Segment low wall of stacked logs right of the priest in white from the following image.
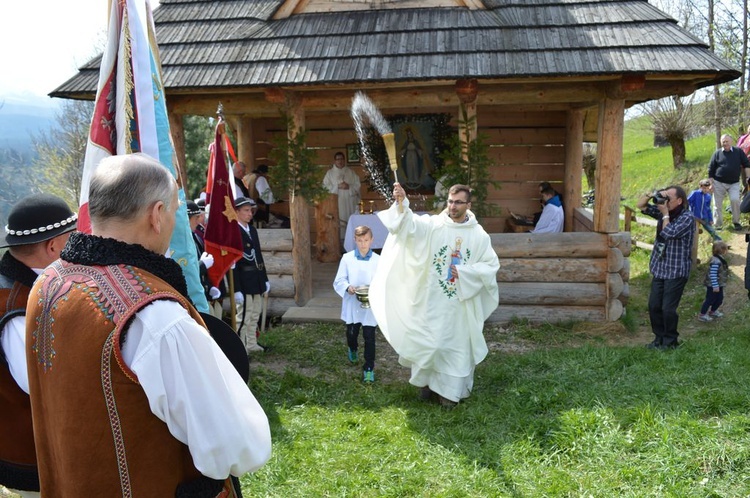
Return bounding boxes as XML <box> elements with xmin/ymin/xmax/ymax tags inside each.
<box><xmin>488</xmin><ymin>232</ymin><xmax>631</xmax><ymax>323</ymax></box>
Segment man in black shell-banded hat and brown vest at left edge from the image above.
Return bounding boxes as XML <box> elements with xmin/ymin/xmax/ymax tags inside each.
<box><xmin>0</xmin><ymin>194</ymin><xmax>77</xmax><ymax>497</ymax></box>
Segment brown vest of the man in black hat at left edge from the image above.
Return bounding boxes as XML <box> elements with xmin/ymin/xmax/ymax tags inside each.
<box><xmin>0</xmin><ymin>276</ymin><xmax>39</xmax><ymax>491</ymax></box>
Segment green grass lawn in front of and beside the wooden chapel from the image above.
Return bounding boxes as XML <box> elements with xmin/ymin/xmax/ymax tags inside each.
<box><xmin>236</xmin><ymin>121</ymin><xmax>750</xmax><ymax>497</ymax></box>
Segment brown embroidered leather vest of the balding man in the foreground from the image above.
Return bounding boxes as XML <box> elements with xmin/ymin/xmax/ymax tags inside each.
<box><xmin>26</xmin><ymin>260</ymin><xmax>234</xmax><ymax>498</ymax></box>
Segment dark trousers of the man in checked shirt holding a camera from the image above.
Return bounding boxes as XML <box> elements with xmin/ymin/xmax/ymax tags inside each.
<box><xmin>648</xmin><ymin>277</ymin><xmax>687</xmax><ymax>346</ymax></box>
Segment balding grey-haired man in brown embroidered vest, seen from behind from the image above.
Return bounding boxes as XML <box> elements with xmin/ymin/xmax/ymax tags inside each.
<box><xmin>26</xmin><ymin>154</ymin><xmax>271</xmax><ymax>498</ymax></box>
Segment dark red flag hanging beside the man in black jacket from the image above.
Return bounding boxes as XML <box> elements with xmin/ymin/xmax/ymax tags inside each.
<box><xmin>203</xmin><ymin>122</ymin><xmax>242</xmax><ymax>287</ymax></box>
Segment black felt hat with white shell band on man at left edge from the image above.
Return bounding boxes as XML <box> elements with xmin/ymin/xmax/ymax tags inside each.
<box><xmin>0</xmin><ymin>194</ymin><xmax>78</xmax><ymax>247</ymax></box>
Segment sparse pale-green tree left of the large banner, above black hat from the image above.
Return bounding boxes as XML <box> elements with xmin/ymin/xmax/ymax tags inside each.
<box><xmin>32</xmin><ymin>100</ymin><xmax>94</xmax><ymax>206</ymax></box>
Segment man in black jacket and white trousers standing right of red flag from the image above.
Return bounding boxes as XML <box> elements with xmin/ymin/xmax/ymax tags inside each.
<box><xmin>234</xmin><ymin>197</ymin><xmax>271</xmax><ymax>354</ymax></box>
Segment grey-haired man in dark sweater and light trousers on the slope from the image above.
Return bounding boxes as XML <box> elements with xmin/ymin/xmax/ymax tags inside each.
<box><xmin>708</xmin><ymin>135</ymin><xmax>750</xmax><ymax>230</ymax></box>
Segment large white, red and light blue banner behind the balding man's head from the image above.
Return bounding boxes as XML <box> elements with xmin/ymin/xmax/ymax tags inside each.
<box><xmin>78</xmin><ymin>0</ymin><xmax>208</xmax><ymax>312</ymax></box>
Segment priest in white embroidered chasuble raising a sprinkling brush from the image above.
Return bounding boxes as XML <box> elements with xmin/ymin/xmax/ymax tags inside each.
<box><xmin>369</xmin><ymin>183</ymin><xmax>499</xmax><ymax>407</ymax></box>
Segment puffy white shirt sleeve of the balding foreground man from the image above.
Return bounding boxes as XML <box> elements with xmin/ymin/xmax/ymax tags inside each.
<box><xmin>122</xmin><ymin>300</ymin><xmax>271</xmax><ymax>479</ymax></box>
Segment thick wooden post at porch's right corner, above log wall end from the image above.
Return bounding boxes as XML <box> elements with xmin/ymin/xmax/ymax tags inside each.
<box><xmin>594</xmin><ymin>98</ymin><xmax>625</xmax><ymax>233</ymax></box>
